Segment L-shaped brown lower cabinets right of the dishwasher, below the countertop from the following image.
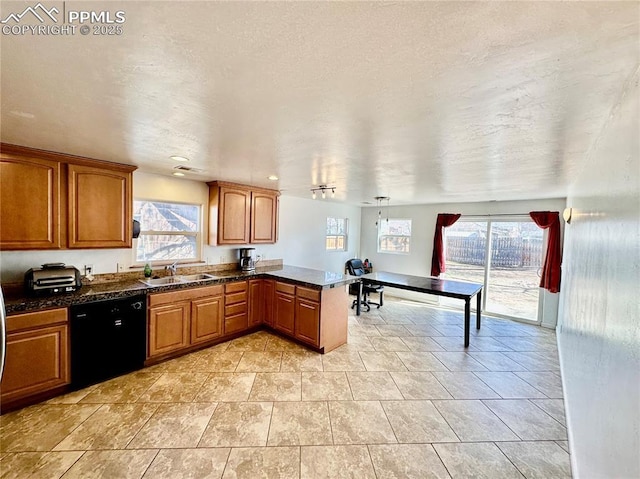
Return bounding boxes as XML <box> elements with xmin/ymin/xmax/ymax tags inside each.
<box><xmin>147</xmin><ymin>278</ymin><xmax>347</xmax><ymax>362</ymax></box>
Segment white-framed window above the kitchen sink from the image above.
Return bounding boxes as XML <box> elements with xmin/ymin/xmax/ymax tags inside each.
<box><xmin>133</xmin><ymin>200</ymin><xmax>201</xmax><ymax>263</ymax></box>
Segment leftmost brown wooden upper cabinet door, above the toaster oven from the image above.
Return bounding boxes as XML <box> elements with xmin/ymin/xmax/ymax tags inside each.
<box><xmin>0</xmin><ymin>154</ymin><xmax>66</xmax><ymax>250</ymax></box>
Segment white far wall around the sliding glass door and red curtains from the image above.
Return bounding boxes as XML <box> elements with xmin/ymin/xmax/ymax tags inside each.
<box><xmin>361</xmin><ymin>199</ymin><xmax>566</xmax><ymax>327</ymax></box>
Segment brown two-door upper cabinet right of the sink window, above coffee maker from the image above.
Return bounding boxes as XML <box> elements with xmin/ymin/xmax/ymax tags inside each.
<box><xmin>207</xmin><ymin>181</ymin><xmax>280</xmax><ymax>245</ymax></box>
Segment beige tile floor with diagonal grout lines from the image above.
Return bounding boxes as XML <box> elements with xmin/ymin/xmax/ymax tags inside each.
<box><xmin>0</xmin><ymin>298</ymin><xmax>571</xmax><ymax>479</ymax></box>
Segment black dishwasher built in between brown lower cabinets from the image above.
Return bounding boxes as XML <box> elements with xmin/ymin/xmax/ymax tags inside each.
<box><xmin>71</xmin><ymin>295</ymin><xmax>147</xmax><ymax>389</ymax></box>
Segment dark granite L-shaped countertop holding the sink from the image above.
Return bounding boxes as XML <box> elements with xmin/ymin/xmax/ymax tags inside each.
<box><xmin>5</xmin><ymin>265</ymin><xmax>358</xmax><ymax>314</ymax></box>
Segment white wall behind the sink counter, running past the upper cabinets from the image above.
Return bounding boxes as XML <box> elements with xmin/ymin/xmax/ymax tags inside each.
<box><xmin>0</xmin><ymin>171</ymin><xmax>360</xmax><ymax>282</ymax></box>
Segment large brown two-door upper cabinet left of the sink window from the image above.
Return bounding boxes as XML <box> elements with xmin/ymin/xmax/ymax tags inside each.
<box><xmin>0</xmin><ymin>143</ymin><xmax>136</xmax><ymax>250</ymax></box>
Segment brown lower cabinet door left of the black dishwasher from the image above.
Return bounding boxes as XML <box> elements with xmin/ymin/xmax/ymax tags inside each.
<box><xmin>0</xmin><ymin>324</ymin><xmax>69</xmax><ymax>403</ymax></box>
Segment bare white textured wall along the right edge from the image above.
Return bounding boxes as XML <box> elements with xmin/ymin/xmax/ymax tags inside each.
<box><xmin>558</xmin><ymin>71</ymin><xmax>640</xmax><ymax>479</ymax></box>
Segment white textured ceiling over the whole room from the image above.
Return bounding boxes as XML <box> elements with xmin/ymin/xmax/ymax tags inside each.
<box><xmin>0</xmin><ymin>1</ymin><xmax>640</xmax><ymax>204</ymax></box>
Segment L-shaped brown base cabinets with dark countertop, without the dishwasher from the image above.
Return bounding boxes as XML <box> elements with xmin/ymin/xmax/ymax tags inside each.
<box><xmin>1</xmin><ymin>265</ymin><xmax>357</xmax><ymax>410</ymax></box>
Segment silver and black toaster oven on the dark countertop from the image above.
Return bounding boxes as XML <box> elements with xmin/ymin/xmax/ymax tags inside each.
<box><xmin>24</xmin><ymin>263</ymin><xmax>82</xmax><ymax>296</ymax></box>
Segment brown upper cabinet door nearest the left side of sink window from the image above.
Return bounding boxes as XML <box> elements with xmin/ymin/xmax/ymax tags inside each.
<box><xmin>68</xmin><ymin>165</ymin><xmax>133</xmax><ymax>248</ymax></box>
